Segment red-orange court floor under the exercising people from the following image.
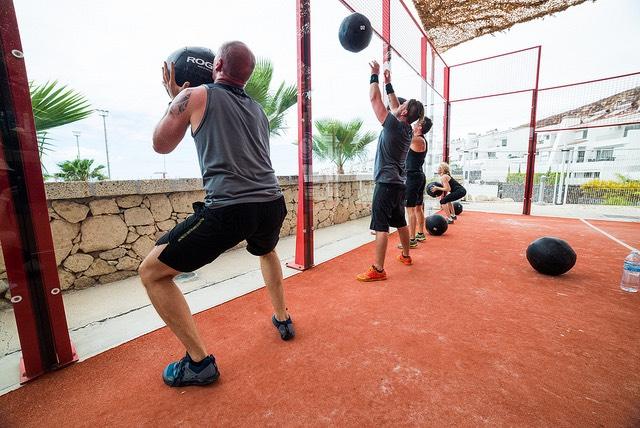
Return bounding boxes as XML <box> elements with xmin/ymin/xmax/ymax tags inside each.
<box><xmin>0</xmin><ymin>212</ymin><xmax>640</xmax><ymax>427</ymax></box>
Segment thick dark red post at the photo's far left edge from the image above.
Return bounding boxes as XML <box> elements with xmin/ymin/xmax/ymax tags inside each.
<box><xmin>0</xmin><ymin>0</ymin><xmax>78</xmax><ymax>382</ymax></box>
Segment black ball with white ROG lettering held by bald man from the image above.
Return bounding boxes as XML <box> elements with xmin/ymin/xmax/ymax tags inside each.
<box><xmin>167</xmin><ymin>47</ymin><xmax>215</xmax><ymax>88</ymax></box>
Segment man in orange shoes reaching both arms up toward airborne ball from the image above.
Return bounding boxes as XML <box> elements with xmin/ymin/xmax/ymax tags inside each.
<box><xmin>357</xmin><ymin>61</ymin><xmax>424</xmax><ymax>281</ymax></box>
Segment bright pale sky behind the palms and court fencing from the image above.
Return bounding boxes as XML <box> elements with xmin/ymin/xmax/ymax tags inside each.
<box><xmin>14</xmin><ymin>0</ymin><xmax>640</xmax><ymax>179</ymax></box>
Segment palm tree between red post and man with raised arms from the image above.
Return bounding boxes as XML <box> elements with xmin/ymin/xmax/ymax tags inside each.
<box><xmin>313</xmin><ymin>119</ymin><xmax>377</xmax><ymax>174</ymax></box>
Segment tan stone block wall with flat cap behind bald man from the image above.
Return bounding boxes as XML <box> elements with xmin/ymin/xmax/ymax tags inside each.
<box><xmin>0</xmin><ymin>176</ymin><xmax>373</xmax><ymax>306</ymax></box>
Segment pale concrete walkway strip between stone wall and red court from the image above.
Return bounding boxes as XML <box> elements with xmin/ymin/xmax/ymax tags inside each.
<box><xmin>0</xmin><ymin>217</ymin><xmax>374</xmax><ymax>395</ymax></box>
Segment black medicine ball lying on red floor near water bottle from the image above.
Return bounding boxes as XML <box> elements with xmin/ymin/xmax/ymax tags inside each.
<box><xmin>527</xmin><ymin>236</ymin><xmax>577</xmax><ymax>276</ymax></box>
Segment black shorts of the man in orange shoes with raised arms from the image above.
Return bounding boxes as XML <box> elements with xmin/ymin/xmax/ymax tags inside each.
<box><xmin>369</xmin><ymin>183</ymin><xmax>407</xmax><ymax>232</ymax></box>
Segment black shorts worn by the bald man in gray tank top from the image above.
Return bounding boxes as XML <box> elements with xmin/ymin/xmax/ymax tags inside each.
<box><xmin>156</xmin><ymin>198</ymin><xmax>287</xmax><ymax>272</ymax></box>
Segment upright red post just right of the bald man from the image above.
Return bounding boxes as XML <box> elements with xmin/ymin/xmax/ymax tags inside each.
<box><xmin>287</xmin><ymin>0</ymin><xmax>313</xmax><ymax>270</ymax></box>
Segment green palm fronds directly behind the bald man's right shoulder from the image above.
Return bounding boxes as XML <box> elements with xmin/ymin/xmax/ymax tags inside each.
<box><xmin>244</xmin><ymin>58</ymin><xmax>298</xmax><ymax>135</ymax></box>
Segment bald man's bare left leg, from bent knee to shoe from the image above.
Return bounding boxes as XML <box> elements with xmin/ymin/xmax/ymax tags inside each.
<box><xmin>139</xmin><ymin>244</ymin><xmax>208</xmax><ymax>361</ymax></box>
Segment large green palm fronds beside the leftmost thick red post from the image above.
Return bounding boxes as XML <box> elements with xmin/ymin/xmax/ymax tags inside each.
<box><xmin>29</xmin><ymin>80</ymin><xmax>93</xmax><ymax>158</ymax></box>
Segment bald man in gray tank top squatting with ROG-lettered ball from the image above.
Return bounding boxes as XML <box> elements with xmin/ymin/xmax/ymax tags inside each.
<box><xmin>140</xmin><ymin>41</ymin><xmax>295</xmax><ymax>386</ymax></box>
